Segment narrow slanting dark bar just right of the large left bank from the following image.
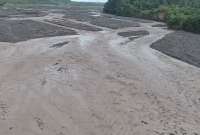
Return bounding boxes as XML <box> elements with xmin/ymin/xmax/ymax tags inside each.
<box><xmin>46</xmin><ymin>20</ymin><xmax>102</xmax><ymax>31</ymax></box>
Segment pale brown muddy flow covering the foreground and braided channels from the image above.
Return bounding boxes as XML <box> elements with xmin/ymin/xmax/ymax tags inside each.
<box><xmin>0</xmin><ymin>4</ymin><xmax>200</xmax><ymax>135</ymax></box>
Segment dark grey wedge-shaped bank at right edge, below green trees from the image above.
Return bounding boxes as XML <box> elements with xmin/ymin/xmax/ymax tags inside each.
<box><xmin>151</xmin><ymin>31</ymin><xmax>200</xmax><ymax>67</ymax></box>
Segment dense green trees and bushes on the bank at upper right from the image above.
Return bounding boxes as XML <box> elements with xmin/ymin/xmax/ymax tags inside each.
<box><xmin>104</xmin><ymin>0</ymin><xmax>200</xmax><ymax>33</ymax></box>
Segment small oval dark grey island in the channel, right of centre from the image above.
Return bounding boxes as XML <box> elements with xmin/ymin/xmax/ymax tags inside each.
<box><xmin>118</xmin><ymin>30</ymin><xmax>149</xmax><ymax>37</ymax></box>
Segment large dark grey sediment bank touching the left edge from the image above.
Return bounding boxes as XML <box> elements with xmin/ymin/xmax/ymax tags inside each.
<box><xmin>0</xmin><ymin>20</ymin><xmax>77</xmax><ymax>43</ymax></box>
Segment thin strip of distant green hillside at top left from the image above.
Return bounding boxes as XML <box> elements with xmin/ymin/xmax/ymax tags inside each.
<box><xmin>0</xmin><ymin>0</ymin><xmax>70</xmax><ymax>4</ymax></box>
